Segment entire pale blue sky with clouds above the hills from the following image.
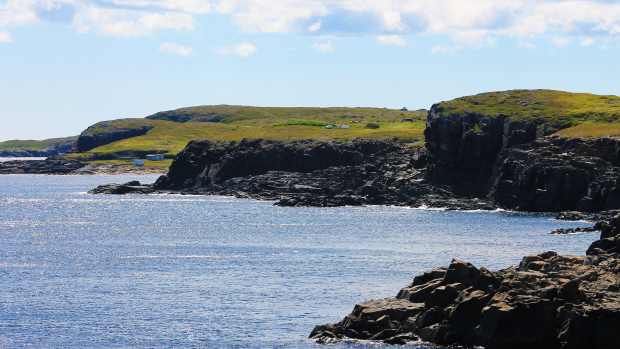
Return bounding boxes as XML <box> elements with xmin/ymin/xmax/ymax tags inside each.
<box><xmin>0</xmin><ymin>0</ymin><xmax>620</xmax><ymax>140</ymax></box>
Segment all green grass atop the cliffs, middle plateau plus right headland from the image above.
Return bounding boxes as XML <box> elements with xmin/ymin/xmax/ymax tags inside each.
<box><xmin>54</xmin><ymin>90</ymin><xmax>620</xmax><ymax>171</ymax></box>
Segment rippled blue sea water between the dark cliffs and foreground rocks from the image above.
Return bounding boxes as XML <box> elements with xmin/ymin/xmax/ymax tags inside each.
<box><xmin>0</xmin><ymin>175</ymin><xmax>596</xmax><ymax>349</ymax></box>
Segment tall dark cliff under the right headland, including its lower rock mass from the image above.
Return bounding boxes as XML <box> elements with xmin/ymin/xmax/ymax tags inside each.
<box><xmin>425</xmin><ymin>105</ymin><xmax>620</xmax><ymax>212</ymax></box>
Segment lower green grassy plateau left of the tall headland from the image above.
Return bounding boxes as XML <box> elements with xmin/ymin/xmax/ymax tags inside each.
<box><xmin>72</xmin><ymin>106</ymin><xmax>426</xmax><ymax>158</ymax></box>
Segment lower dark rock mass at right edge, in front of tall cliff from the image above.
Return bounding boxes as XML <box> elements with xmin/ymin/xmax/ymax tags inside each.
<box><xmin>491</xmin><ymin>138</ymin><xmax>620</xmax><ymax>212</ymax></box>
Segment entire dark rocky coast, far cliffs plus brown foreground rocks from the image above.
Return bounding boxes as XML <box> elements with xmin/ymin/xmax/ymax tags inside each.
<box><xmin>83</xmin><ymin>107</ymin><xmax>620</xmax><ymax>349</ymax></box>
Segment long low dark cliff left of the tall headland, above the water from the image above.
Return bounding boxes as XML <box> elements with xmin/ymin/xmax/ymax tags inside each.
<box><xmin>140</xmin><ymin>140</ymin><xmax>492</xmax><ymax>209</ymax></box>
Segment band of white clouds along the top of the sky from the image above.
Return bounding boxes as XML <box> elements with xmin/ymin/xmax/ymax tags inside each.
<box><xmin>0</xmin><ymin>0</ymin><xmax>620</xmax><ymax>51</ymax></box>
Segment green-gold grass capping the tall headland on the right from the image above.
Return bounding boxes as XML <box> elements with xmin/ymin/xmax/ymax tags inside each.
<box><xmin>436</xmin><ymin>90</ymin><xmax>620</xmax><ymax>128</ymax></box>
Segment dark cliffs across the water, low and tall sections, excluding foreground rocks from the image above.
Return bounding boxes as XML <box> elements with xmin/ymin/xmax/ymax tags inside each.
<box><xmin>93</xmin><ymin>106</ymin><xmax>620</xmax><ymax>213</ymax></box>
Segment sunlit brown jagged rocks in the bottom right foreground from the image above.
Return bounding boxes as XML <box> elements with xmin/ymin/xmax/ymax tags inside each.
<box><xmin>310</xmin><ymin>216</ymin><xmax>620</xmax><ymax>349</ymax></box>
